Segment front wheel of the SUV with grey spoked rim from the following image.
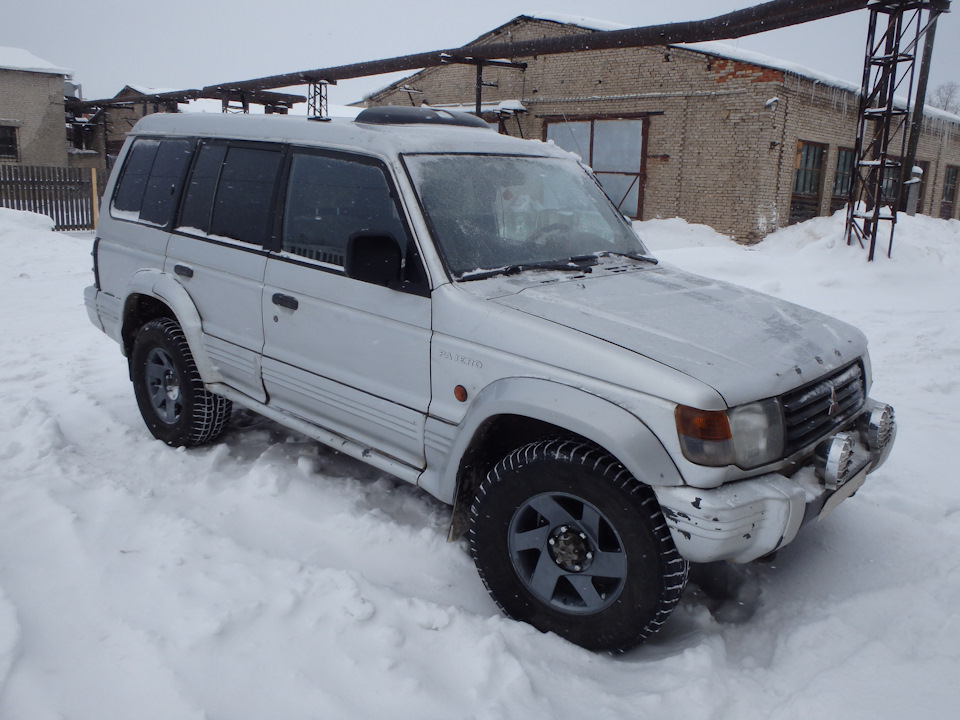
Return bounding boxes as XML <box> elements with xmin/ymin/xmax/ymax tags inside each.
<box><xmin>469</xmin><ymin>438</ymin><xmax>688</xmax><ymax>652</ymax></box>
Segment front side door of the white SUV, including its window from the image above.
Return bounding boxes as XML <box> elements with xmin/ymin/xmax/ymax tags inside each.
<box><xmin>262</xmin><ymin>148</ymin><xmax>430</xmax><ymax>468</ymax></box>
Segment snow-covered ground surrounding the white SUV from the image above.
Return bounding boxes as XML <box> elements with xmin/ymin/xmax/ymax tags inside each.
<box><xmin>0</xmin><ymin>209</ymin><xmax>960</xmax><ymax>720</ymax></box>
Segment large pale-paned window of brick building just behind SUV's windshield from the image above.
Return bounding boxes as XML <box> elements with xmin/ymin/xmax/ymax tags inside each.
<box><xmin>547</xmin><ymin>118</ymin><xmax>645</xmax><ymax>219</ymax></box>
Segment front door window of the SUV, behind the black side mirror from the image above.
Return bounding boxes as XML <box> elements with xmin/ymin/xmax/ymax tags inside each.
<box><xmin>282</xmin><ymin>153</ymin><xmax>407</xmax><ymax>267</ymax></box>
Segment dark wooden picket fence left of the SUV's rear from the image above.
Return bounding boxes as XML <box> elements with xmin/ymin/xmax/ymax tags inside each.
<box><xmin>0</xmin><ymin>165</ymin><xmax>105</xmax><ymax>230</ymax></box>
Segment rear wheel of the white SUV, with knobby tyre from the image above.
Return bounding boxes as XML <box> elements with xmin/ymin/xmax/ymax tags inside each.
<box><xmin>130</xmin><ymin>318</ymin><xmax>232</xmax><ymax>447</ymax></box>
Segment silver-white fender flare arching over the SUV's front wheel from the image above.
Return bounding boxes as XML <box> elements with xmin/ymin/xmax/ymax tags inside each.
<box><xmin>432</xmin><ymin>377</ymin><xmax>686</xmax><ymax>502</ymax></box>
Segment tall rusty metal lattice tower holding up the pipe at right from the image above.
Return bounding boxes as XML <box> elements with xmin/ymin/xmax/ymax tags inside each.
<box><xmin>846</xmin><ymin>0</ymin><xmax>950</xmax><ymax>260</ymax></box>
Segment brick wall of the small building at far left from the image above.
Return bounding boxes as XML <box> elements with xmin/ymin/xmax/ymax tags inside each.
<box><xmin>0</xmin><ymin>69</ymin><xmax>67</xmax><ymax>166</ymax></box>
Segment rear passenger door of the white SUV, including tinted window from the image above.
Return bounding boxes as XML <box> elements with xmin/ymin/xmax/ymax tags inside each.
<box><xmin>164</xmin><ymin>141</ymin><xmax>284</xmax><ymax>402</ymax></box>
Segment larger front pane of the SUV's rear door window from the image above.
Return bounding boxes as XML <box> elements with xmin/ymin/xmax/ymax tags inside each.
<box><xmin>210</xmin><ymin>147</ymin><xmax>282</xmax><ymax>245</ymax></box>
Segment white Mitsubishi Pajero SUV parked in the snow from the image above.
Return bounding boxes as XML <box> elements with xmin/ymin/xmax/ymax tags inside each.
<box><xmin>85</xmin><ymin>107</ymin><xmax>896</xmax><ymax>650</ymax></box>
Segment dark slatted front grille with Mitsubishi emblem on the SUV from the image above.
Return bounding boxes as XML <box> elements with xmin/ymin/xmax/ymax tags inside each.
<box><xmin>781</xmin><ymin>362</ymin><xmax>866</xmax><ymax>455</ymax></box>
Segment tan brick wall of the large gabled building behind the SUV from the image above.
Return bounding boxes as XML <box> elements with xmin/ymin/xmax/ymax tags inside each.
<box><xmin>367</xmin><ymin>18</ymin><xmax>960</xmax><ymax>242</ymax></box>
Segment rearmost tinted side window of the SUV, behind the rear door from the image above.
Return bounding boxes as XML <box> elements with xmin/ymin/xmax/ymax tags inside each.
<box><xmin>113</xmin><ymin>138</ymin><xmax>194</xmax><ymax>226</ymax></box>
